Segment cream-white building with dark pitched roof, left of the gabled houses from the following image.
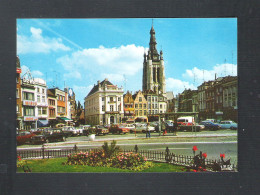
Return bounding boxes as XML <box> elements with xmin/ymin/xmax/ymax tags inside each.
<box><xmin>84</xmin><ymin>79</ymin><xmax>124</xmax><ymax>125</ymax></box>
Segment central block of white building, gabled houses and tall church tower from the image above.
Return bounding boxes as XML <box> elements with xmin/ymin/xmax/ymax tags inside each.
<box><xmin>84</xmin><ymin>26</ymin><xmax>173</xmax><ymax>124</ymax></box>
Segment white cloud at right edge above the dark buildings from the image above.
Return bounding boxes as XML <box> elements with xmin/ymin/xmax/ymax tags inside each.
<box><xmin>182</xmin><ymin>64</ymin><xmax>237</xmax><ymax>84</ymax></box>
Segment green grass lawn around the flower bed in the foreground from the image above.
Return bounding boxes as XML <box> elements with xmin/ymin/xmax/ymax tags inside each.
<box><xmin>17</xmin><ymin>158</ymin><xmax>186</xmax><ymax>173</ymax></box>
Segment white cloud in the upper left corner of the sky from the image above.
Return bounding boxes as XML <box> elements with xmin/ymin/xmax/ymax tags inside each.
<box><xmin>17</xmin><ymin>27</ymin><xmax>70</xmax><ymax>54</ymax></box>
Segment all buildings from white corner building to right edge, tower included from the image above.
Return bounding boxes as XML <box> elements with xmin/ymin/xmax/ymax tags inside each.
<box><xmin>84</xmin><ymin>23</ymin><xmax>237</xmax><ymax>124</ymax></box>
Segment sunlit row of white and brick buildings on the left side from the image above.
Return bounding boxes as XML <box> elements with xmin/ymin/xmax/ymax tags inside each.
<box><xmin>16</xmin><ymin>56</ymin><xmax>84</xmax><ymax>130</ymax></box>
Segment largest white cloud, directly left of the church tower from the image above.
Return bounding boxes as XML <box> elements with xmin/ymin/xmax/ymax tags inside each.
<box><xmin>57</xmin><ymin>45</ymin><xmax>145</xmax><ymax>81</ymax></box>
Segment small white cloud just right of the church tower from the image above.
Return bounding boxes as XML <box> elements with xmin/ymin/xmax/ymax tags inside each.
<box><xmin>166</xmin><ymin>78</ymin><xmax>197</xmax><ymax>95</ymax></box>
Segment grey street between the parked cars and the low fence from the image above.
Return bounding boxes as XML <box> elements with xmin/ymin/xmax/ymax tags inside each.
<box><xmin>17</xmin><ymin>130</ymin><xmax>237</xmax><ymax>163</ymax></box>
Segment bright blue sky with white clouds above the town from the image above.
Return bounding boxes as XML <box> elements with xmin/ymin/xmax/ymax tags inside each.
<box><xmin>17</xmin><ymin>18</ymin><xmax>237</xmax><ymax>104</ymax></box>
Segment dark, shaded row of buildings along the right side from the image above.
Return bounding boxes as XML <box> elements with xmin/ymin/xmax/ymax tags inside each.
<box><xmin>175</xmin><ymin>76</ymin><xmax>238</xmax><ymax>122</ymax></box>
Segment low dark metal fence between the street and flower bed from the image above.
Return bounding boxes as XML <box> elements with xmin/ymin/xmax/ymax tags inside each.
<box><xmin>17</xmin><ymin>145</ymin><xmax>237</xmax><ymax>171</ymax></box>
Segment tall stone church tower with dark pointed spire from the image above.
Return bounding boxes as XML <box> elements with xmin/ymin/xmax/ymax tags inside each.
<box><xmin>143</xmin><ymin>25</ymin><xmax>166</xmax><ymax>95</ymax></box>
